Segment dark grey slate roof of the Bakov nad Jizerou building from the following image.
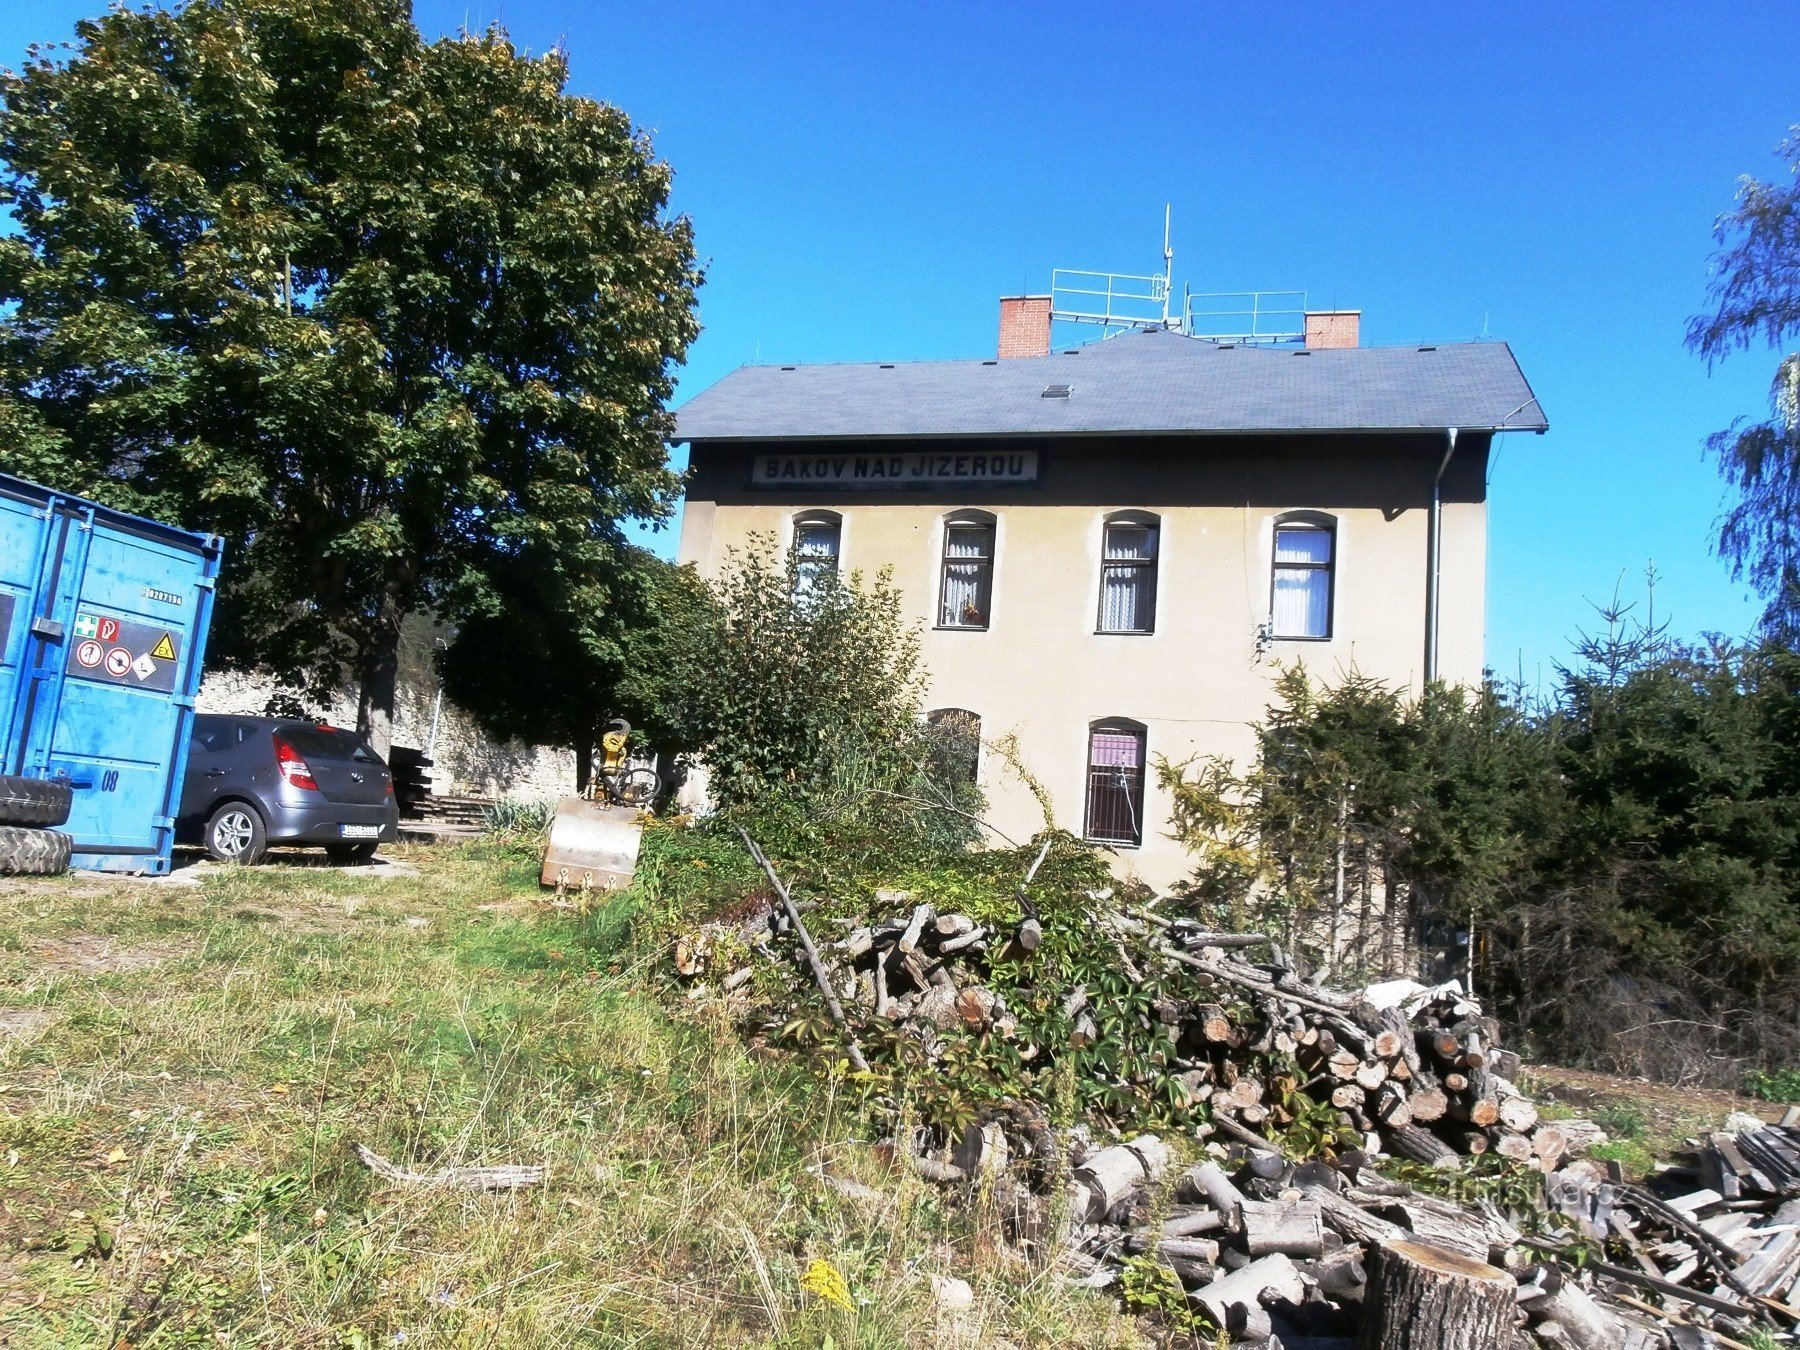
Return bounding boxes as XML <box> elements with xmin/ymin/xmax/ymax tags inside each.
<box><xmin>671</xmin><ymin>329</ymin><xmax>1548</xmax><ymax>441</ymax></box>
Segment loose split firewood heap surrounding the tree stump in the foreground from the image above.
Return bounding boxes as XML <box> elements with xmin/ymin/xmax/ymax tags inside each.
<box><xmin>1058</xmin><ymin>1127</ymin><xmax>1800</xmax><ymax>1350</ymax></box>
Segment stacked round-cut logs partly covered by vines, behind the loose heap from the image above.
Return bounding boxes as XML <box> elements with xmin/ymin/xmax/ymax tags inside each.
<box><xmin>810</xmin><ymin>893</ymin><xmax>1600</xmax><ymax>1172</ymax></box>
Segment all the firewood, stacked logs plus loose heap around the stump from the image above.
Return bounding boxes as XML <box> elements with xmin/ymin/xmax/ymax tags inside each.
<box><xmin>677</xmin><ymin>841</ymin><xmax>1800</xmax><ymax>1350</ymax></box>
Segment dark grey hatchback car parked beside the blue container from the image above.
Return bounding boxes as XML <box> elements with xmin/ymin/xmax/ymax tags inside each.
<box><xmin>175</xmin><ymin>713</ymin><xmax>400</xmax><ymax>862</ymax></box>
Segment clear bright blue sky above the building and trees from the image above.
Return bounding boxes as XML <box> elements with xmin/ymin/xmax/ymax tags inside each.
<box><xmin>0</xmin><ymin>0</ymin><xmax>1800</xmax><ymax>680</ymax></box>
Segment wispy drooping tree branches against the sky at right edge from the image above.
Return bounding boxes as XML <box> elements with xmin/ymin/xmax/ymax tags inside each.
<box><xmin>1688</xmin><ymin>128</ymin><xmax>1800</xmax><ymax>639</ymax></box>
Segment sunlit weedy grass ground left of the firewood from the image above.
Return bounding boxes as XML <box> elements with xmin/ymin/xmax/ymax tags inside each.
<box><xmin>0</xmin><ymin>842</ymin><xmax>1141</xmax><ymax>1346</ymax></box>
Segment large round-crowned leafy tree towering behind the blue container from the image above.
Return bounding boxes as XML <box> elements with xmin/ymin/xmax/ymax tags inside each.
<box><xmin>0</xmin><ymin>0</ymin><xmax>700</xmax><ymax>745</ymax></box>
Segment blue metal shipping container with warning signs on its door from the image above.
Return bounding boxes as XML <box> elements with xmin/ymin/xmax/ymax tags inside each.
<box><xmin>0</xmin><ymin>473</ymin><xmax>223</xmax><ymax>875</ymax></box>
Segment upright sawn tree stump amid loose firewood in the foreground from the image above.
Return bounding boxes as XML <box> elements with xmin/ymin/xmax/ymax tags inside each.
<box><xmin>1357</xmin><ymin>1242</ymin><xmax>1516</xmax><ymax>1350</ymax></box>
